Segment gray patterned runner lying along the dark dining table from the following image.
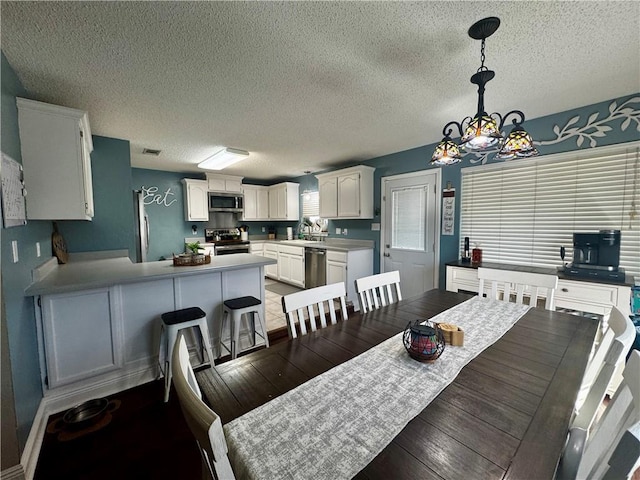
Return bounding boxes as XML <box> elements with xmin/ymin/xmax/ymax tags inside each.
<box><xmin>224</xmin><ymin>297</ymin><xmax>530</xmax><ymax>480</ymax></box>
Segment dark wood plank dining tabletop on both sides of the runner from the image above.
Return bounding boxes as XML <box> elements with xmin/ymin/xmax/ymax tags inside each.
<box><xmin>197</xmin><ymin>290</ymin><xmax>598</xmax><ymax>479</ymax></box>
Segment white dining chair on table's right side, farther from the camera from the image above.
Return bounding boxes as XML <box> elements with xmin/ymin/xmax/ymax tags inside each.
<box><xmin>575</xmin><ymin>307</ymin><xmax>636</xmax><ymax>413</ymax></box>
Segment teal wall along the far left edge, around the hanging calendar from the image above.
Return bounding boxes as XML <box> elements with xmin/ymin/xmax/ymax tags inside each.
<box><xmin>0</xmin><ymin>54</ymin><xmax>51</xmax><ymax>451</ymax></box>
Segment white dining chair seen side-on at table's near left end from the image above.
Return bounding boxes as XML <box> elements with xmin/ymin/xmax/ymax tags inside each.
<box><xmin>172</xmin><ymin>333</ymin><xmax>235</xmax><ymax>480</ymax></box>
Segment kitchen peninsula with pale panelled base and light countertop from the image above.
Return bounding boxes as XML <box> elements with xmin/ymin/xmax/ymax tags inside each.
<box><xmin>25</xmin><ymin>252</ymin><xmax>274</xmax><ymax>411</ymax></box>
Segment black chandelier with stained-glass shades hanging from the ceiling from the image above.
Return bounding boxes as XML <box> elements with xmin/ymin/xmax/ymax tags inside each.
<box><xmin>431</xmin><ymin>17</ymin><xmax>538</xmax><ymax>165</ymax></box>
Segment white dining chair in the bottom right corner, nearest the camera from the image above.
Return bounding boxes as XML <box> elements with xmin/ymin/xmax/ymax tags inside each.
<box><xmin>556</xmin><ymin>348</ymin><xmax>640</xmax><ymax>480</ymax></box>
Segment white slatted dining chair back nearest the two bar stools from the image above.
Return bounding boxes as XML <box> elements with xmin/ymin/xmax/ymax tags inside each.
<box><xmin>282</xmin><ymin>282</ymin><xmax>347</xmax><ymax>338</ymax></box>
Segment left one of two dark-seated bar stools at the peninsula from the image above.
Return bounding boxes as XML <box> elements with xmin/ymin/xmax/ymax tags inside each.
<box><xmin>158</xmin><ymin>307</ymin><xmax>214</xmax><ymax>402</ymax></box>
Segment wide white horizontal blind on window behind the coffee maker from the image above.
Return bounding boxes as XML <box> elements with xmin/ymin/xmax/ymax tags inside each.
<box><xmin>460</xmin><ymin>142</ymin><xmax>640</xmax><ymax>277</ymax></box>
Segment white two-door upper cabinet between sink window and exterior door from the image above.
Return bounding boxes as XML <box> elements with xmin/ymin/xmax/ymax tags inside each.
<box><xmin>316</xmin><ymin>165</ymin><xmax>375</xmax><ymax>219</ymax></box>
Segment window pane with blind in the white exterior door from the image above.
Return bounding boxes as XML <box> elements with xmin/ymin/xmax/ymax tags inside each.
<box><xmin>391</xmin><ymin>187</ymin><xmax>426</xmax><ymax>251</ymax></box>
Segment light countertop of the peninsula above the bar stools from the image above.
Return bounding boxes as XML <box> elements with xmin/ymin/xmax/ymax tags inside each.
<box><xmin>25</xmin><ymin>253</ymin><xmax>276</xmax><ymax>296</ymax></box>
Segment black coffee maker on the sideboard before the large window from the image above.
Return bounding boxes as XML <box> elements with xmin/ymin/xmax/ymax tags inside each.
<box><xmin>564</xmin><ymin>230</ymin><xmax>625</xmax><ymax>282</ymax></box>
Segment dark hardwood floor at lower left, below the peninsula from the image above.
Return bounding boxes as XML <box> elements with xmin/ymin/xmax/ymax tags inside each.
<box><xmin>35</xmin><ymin>328</ymin><xmax>288</xmax><ymax>480</ymax></box>
